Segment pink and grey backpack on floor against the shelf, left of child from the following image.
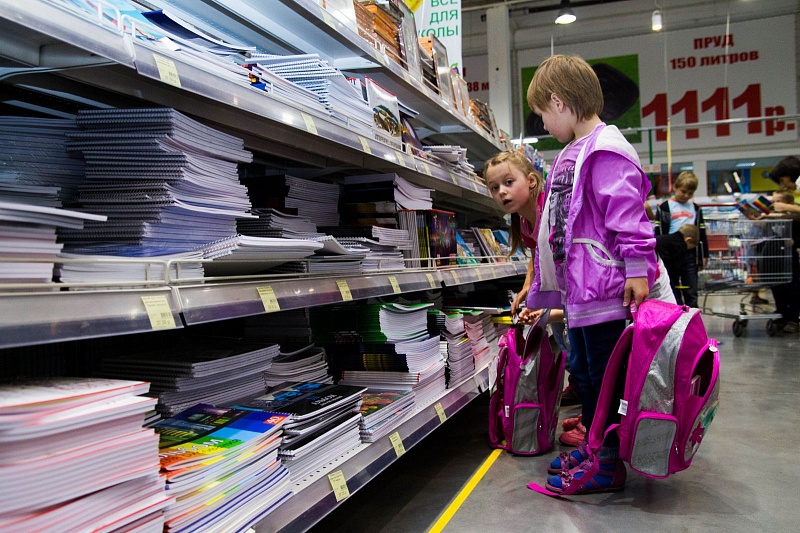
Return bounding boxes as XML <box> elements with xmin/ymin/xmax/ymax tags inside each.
<box><xmin>489</xmin><ymin>311</ymin><xmax>564</xmax><ymax>455</ymax></box>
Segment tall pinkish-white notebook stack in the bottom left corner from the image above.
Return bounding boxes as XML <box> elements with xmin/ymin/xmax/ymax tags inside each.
<box><xmin>0</xmin><ymin>378</ymin><xmax>167</xmax><ymax>531</ymax></box>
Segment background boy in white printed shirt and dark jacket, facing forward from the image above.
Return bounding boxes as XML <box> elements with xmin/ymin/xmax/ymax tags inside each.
<box><xmin>655</xmin><ymin>172</ymin><xmax>709</xmax><ymax>307</ymax></box>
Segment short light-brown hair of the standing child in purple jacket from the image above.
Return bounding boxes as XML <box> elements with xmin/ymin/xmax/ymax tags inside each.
<box><xmin>528</xmin><ymin>55</ymin><xmax>603</xmax><ymax>120</ymax></box>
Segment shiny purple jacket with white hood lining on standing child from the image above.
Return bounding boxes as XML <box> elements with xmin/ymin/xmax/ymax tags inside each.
<box><xmin>526</xmin><ymin>124</ymin><xmax>656</xmax><ymax>327</ymax></box>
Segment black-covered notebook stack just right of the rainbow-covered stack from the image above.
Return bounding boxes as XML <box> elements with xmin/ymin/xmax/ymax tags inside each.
<box><xmin>234</xmin><ymin>382</ymin><xmax>366</xmax><ymax>482</ymax></box>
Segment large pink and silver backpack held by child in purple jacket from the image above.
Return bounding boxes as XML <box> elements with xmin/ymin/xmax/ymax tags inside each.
<box><xmin>528</xmin><ymin>300</ymin><xmax>719</xmax><ymax>495</ymax></box>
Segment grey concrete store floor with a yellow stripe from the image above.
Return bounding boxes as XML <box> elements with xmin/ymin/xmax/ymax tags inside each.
<box><xmin>312</xmin><ymin>304</ymin><xmax>800</xmax><ymax>533</ymax></box>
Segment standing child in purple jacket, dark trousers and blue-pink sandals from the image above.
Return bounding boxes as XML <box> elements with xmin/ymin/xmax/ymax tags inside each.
<box><xmin>527</xmin><ymin>55</ymin><xmax>656</xmax><ymax>494</ymax></box>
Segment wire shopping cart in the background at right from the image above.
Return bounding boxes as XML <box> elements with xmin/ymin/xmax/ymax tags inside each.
<box><xmin>698</xmin><ymin>206</ymin><xmax>792</xmax><ymax>337</ymax></box>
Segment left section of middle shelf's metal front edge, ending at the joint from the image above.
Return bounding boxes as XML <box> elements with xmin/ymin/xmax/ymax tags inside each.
<box><xmin>0</xmin><ymin>287</ymin><xmax>183</xmax><ymax>348</ymax></box>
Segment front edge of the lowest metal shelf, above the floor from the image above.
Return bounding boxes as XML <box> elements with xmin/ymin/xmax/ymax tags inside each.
<box><xmin>254</xmin><ymin>367</ymin><xmax>489</xmax><ymax>532</ymax></box>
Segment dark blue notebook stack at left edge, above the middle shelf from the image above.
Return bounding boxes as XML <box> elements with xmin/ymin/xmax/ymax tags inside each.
<box><xmin>0</xmin><ymin>117</ymin><xmax>84</xmax><ymax>207</ymax></box>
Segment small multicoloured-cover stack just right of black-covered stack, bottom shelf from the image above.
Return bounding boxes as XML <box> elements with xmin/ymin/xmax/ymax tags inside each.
<box><xmin>360</xmin><ymin>388</ymin><xmax>414</xmax><ymax>442</ymax></box>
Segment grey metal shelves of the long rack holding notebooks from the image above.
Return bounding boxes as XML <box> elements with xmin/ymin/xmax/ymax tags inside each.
<box><xmin>0</xmin><ymin>0</ymin><xmax>526</xmax><ymax>531</ymax></box>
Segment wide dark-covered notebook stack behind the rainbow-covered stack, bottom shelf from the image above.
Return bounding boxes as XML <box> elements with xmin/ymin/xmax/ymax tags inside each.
<box><xmin>100</xmin><ymin>338</ymin><xmax>279</xmax><ymax>417</ymax></box>
